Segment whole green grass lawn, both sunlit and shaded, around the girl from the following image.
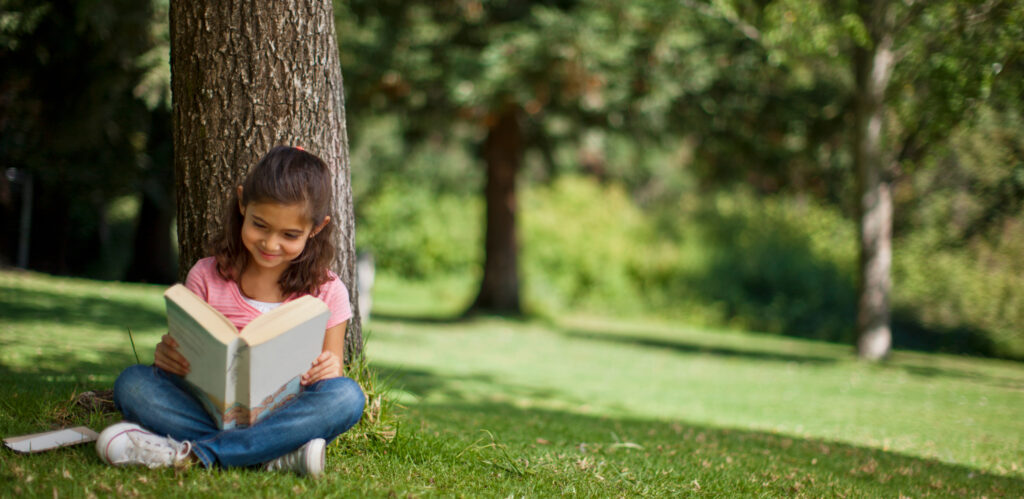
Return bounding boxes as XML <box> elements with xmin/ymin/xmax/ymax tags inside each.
<box><xmin>0</xmin><ymin>273</ymin><xmax>1024</xmax><ymax>497</ymax></box>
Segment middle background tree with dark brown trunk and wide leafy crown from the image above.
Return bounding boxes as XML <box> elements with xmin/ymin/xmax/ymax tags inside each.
<box><xmin>337</xmin><ymin>1</ymin><xmax>749</xmax><ymax>314</ymax></box>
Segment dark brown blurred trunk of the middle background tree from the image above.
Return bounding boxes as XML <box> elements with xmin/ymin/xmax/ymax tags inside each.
<box><xmin>469</xmin><ymin>106</ymin><xmax>523</xmax><ymax>315</ymax></box>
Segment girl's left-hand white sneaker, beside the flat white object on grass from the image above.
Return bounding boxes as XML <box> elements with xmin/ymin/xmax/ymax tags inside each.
<box><xmin>96</xmin><ymin>421</ymin><xmax>191</xmax><ymax>468</ymax></box>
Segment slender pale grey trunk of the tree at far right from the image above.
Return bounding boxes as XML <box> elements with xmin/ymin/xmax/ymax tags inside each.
<box><xmin>853</xmin><ymin>0</ymin><xmax>894</xmax><ymax>361</ymax></box>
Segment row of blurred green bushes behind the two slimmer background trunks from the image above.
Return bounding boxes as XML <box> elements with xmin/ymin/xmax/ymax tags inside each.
<box><xmin>357</xmin><ymin>176</ymin><xmax>1024</xmax><ymax>358</ymax></box>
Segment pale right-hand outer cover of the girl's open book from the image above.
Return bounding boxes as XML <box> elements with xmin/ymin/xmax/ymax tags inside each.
<box><xmin>246</xmin><ymin>307</ymin><xmax>331</xmax><ymax>406</ymax></box>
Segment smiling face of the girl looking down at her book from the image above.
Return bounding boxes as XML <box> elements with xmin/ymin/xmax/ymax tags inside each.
<box><xmin>239</xmin><ymin>199</ymin><xmax>313</xmax><ymax>271</ymax></box>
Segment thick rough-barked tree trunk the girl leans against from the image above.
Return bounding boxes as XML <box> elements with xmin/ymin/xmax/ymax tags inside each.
<box><xmin>170</xmin><ymin>0</ymin><xmax>362</xmax><ymax>361</ymax></box>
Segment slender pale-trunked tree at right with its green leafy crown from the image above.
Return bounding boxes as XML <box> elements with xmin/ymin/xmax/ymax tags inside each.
<box><xmin>733</xmin><ymin>0</ymin><xmax>1020</xmax><ymax>360</ymax></box>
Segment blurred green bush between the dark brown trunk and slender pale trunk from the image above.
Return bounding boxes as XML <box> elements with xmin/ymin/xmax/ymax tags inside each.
<box><xmin>522</xmin><ymin>177</ymin><xmax>856</xmax><ymax>341</ymax></box>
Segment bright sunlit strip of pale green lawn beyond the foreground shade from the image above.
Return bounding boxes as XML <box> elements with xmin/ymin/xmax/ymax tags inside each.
<box><xmin>368</xmin><ymin>311</ymin><xmax>1024</xmax><ymax>479</ymax></box>
